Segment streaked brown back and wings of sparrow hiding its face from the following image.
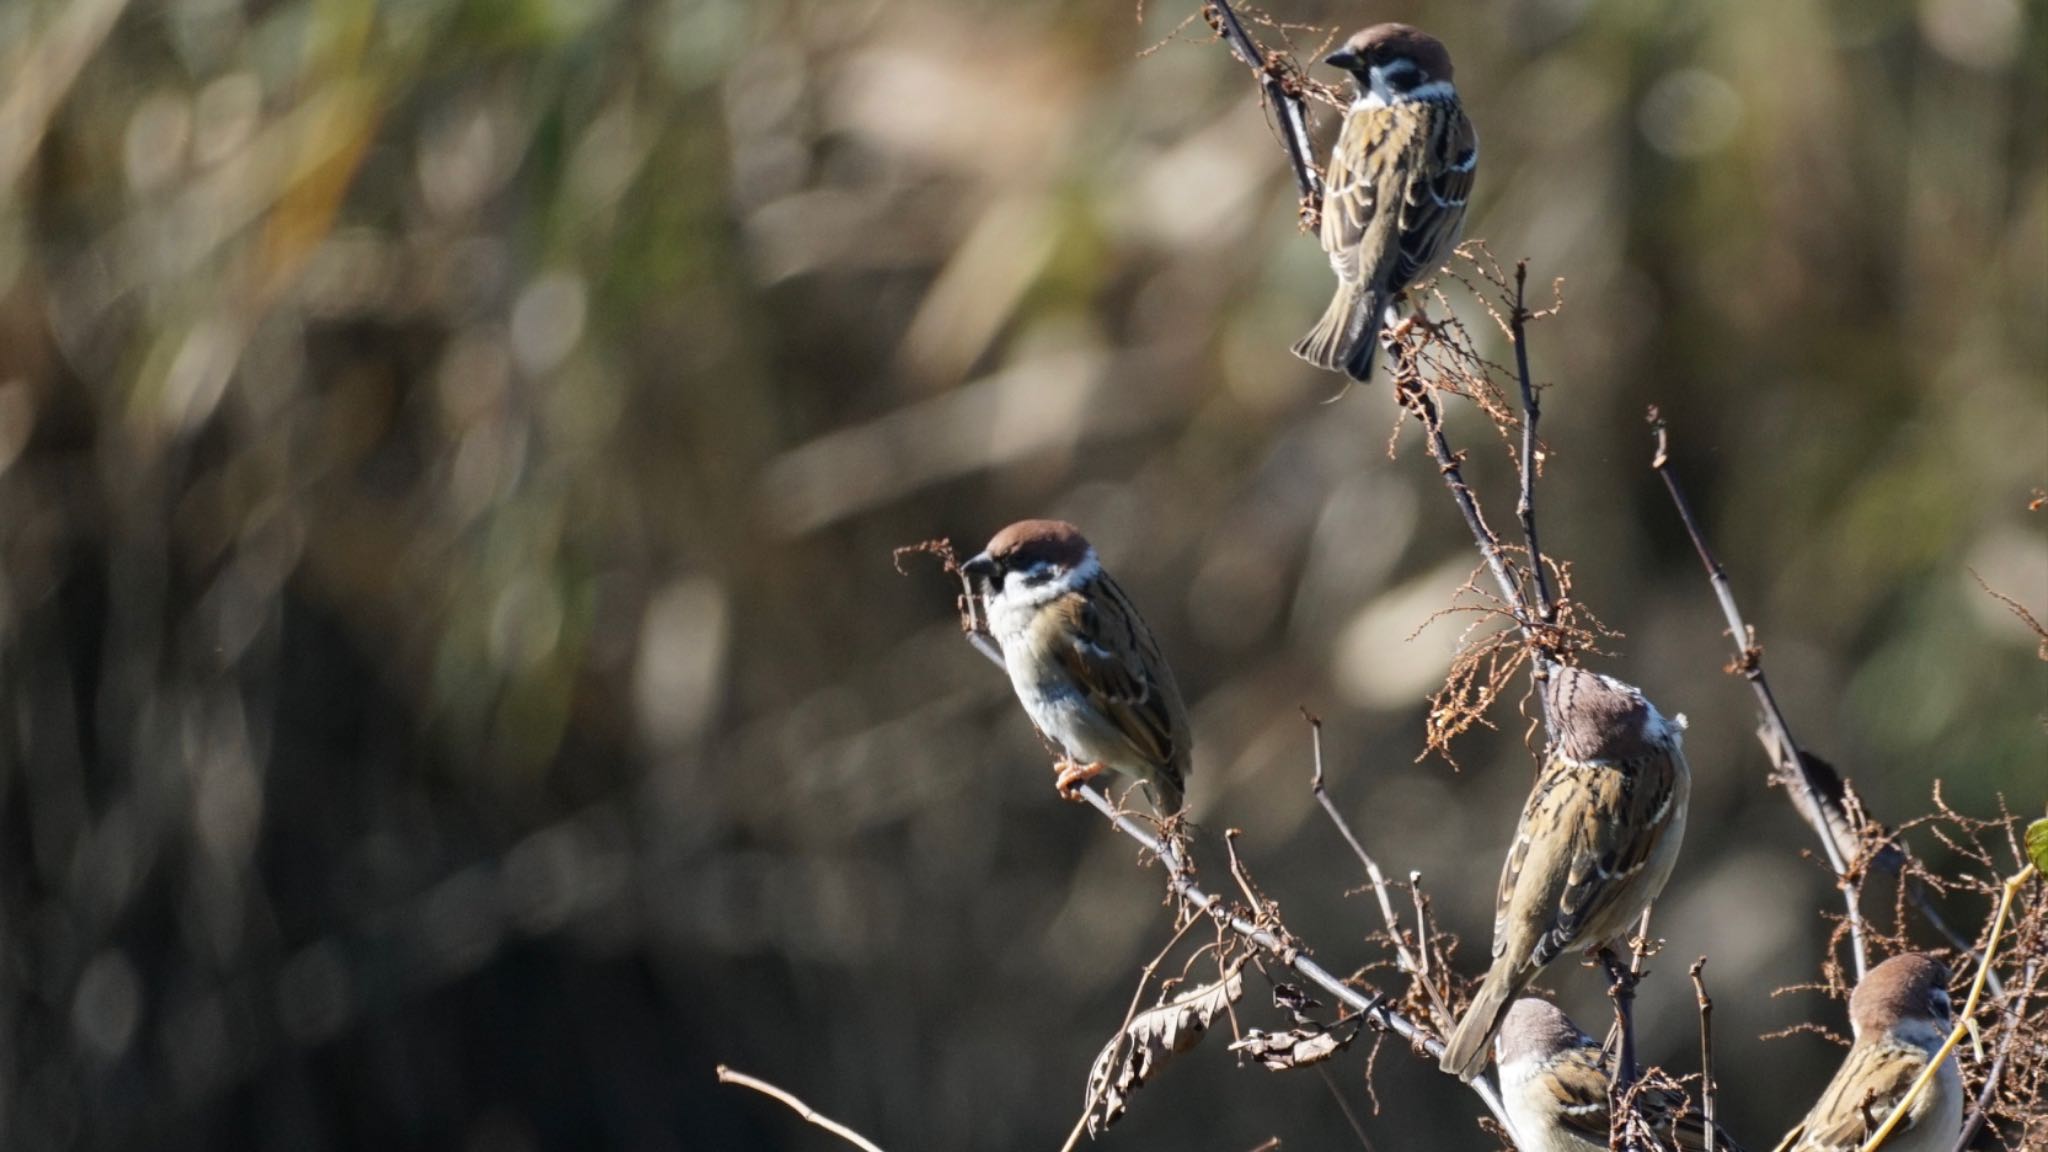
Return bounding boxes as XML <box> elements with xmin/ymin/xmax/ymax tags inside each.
<box><xmin>1493</xmin><ymin>752</ymin><xmax>1677</xmax><ymax>968</ymax></box>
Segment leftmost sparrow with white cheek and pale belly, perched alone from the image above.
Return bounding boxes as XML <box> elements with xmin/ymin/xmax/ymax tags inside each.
<box><xmin>961</xmin><ymin>521</ymin><xmax>1194</xmax><ymax>816</ymax></box>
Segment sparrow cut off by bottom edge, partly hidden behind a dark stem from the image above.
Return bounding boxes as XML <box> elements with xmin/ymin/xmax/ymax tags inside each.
<box><xmin>1493</xmin><ymin>996</ymin><xmax>1741</xmax><ymax>1152</ymax></box>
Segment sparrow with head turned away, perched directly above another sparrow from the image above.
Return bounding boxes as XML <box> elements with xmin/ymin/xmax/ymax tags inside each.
<box><xmin>1442</xmin><ymin>666</ymin><xmax>1692</xmax><ymax>1080</ymax></box>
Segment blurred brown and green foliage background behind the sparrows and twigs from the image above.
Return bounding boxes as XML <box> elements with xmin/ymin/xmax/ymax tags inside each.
<box><xmin>0</xmin><ymin>0</ymin><xmax>2048</xmax><ymax>1152</ymax></box>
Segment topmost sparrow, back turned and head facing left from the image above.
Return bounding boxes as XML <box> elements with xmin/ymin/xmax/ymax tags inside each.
<box><xmin>1294</xmin><ymin>25</ymin><xmax>1479</xmax><ymax>379</ymax></box>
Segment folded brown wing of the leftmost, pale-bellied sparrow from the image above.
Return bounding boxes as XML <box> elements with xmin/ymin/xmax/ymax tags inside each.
<box><xmin>1051</xmin><ymin>576</ymin><xmax>1190</xmax><ymax>785</ymax></box>
